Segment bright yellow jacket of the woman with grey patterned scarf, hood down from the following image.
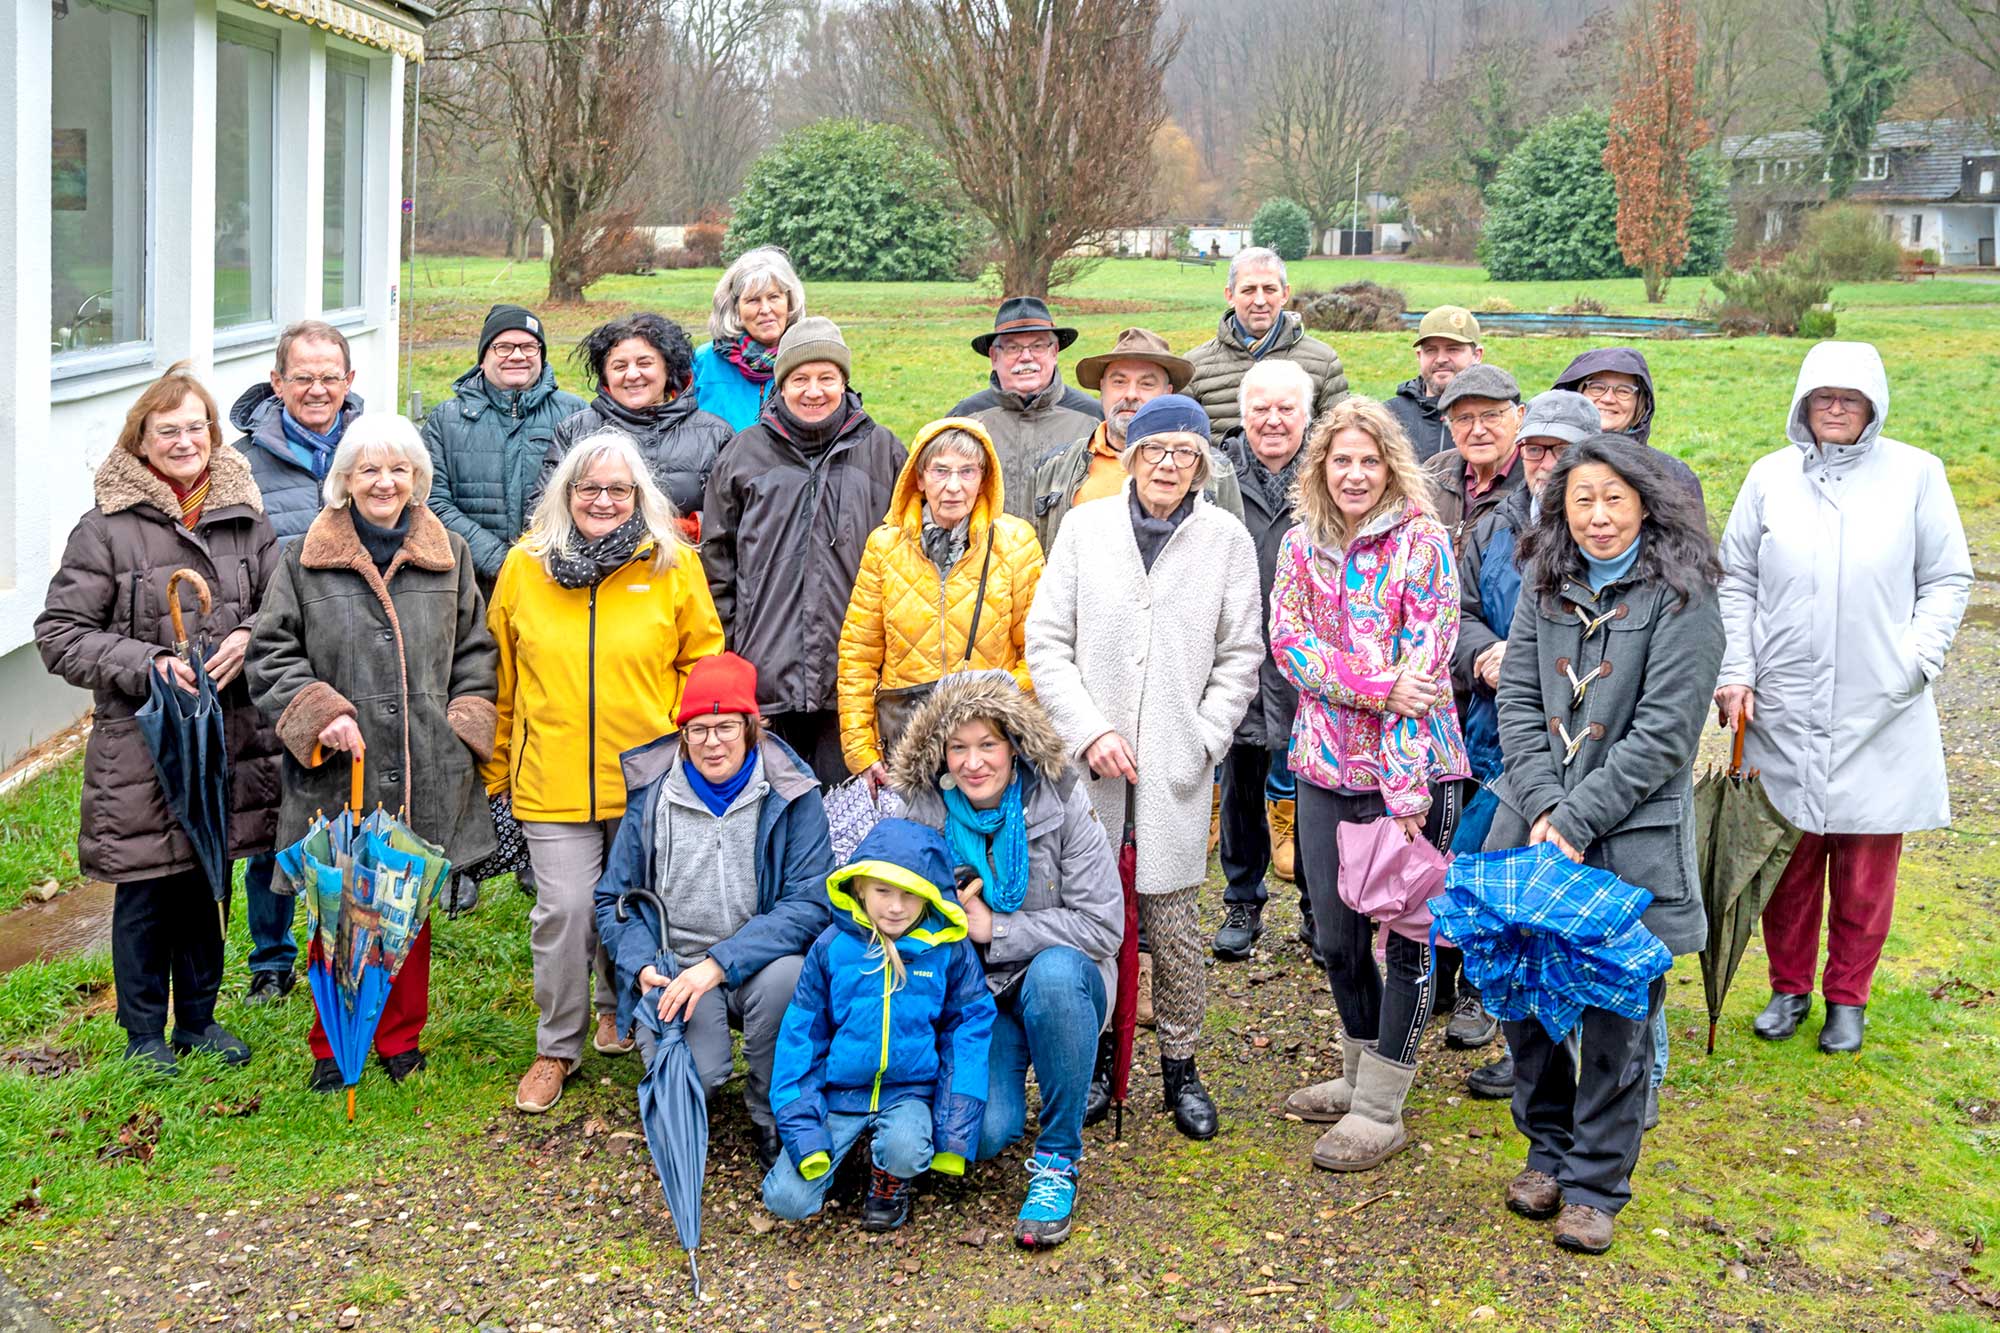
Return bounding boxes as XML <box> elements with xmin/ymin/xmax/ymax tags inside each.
<box><xmin>480</xmin><ymin>544</ymin><xmax>722</xmax><ymax>825</ymax></box>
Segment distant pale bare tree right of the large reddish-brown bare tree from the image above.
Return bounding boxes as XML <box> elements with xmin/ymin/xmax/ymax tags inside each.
<box><xmin>1246</xmin><ymin>0</ymin><xmax>1402</xmax><ymax>250</ymax></box>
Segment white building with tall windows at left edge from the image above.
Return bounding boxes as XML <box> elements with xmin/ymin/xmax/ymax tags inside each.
<box><xmin>0</xmin><ymin>0</ymin><xmax>432</xmax><ymax>769</ymax></box>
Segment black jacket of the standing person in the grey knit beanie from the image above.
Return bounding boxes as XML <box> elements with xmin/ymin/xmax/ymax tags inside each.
<box><xmin>702</xmin><ymin>392</ymin><xmax>908</xmax><ymax>715</ymax></box>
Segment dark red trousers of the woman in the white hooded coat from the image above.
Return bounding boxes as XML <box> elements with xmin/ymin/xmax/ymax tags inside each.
<box><xmin>1764</xmin><ymin>833</ymin><xmax>1902</xmax><ymax>1005</ymax></box>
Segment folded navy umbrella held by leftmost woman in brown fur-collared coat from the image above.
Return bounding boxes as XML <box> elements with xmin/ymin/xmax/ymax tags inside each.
<box><xmin>136</xmin><ymin>568</ymin><xmax>230</xmax><ymax>917</ymax></box>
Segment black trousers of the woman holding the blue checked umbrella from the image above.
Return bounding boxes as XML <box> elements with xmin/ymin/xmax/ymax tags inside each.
<box><xmin>1504</xmin><ymin>977</ymin><xmax>1666</xmax><ymax>1213</ymax></box>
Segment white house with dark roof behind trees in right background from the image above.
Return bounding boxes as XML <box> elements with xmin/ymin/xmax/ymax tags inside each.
<box><xmin>1722</xmin><ymin>120</ymin><xmax>2000</xmax><ymax>268</ymax></box>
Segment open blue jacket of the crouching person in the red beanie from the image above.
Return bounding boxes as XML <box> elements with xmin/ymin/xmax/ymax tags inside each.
<box><xmin>592</xmin><ymin>733</ymin><xmax>834</xmax><ymax>1033</ymax></box>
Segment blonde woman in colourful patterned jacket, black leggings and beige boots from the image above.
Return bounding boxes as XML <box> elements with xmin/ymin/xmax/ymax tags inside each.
<box><xmin>1270</xmin><ymin>396</ymin><xmax>1468</xmax><ymax>1171</ymax></box>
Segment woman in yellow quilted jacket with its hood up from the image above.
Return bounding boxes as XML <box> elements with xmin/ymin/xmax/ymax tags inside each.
<box><xmin>836</xmin><ymin>416</ymin><xmax>1042</xmax><ymax>787</ymax></box>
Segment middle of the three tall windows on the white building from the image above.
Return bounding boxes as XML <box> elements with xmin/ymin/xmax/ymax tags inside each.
<box><xmin>216</xmin><ymin>26</ymin><xmax>278</xmax><ymax>328</ymax></box>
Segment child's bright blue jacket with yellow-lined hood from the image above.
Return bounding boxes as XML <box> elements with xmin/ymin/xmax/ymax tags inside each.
<box><xmin>770</xmin><ymin>819</ymin><xmax>996</xmax><ymax>1179</ymax></box>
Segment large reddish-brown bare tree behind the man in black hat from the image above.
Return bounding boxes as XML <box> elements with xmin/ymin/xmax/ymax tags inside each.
<box><xmin>882</xmin><ymin>0</ymin><xmax>1180</xmax><ymax>296</ymax></box>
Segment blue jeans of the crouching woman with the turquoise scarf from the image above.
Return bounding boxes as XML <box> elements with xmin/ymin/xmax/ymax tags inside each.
<box><xmin>974</xmin><ymin>945</ymin><xmax>1108</xmax><ymax>1161</ymax></box>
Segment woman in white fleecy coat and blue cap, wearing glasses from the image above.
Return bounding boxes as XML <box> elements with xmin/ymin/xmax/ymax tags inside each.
<box><xmin>1028</xmin><ymin>394</ymin><xmax>1264</xmax><ymax>1139</ymax></box>
